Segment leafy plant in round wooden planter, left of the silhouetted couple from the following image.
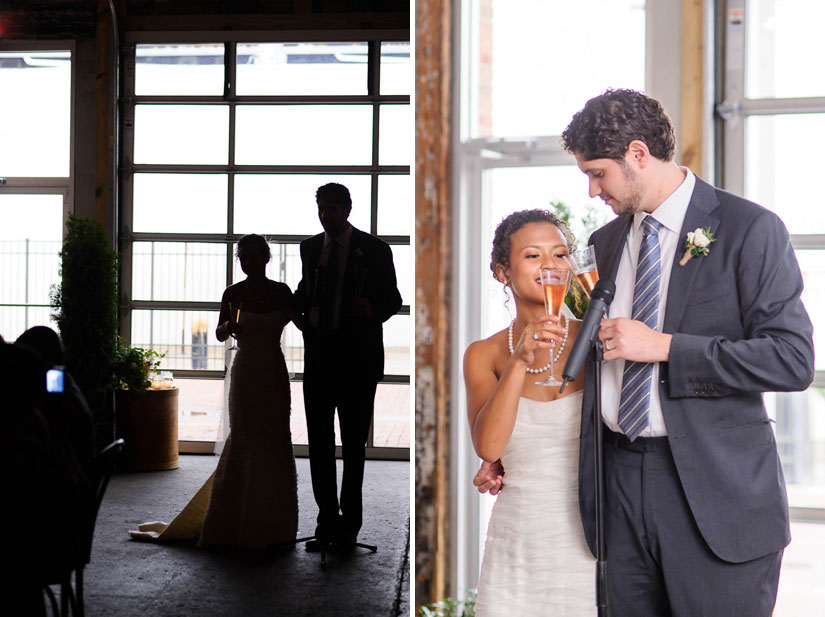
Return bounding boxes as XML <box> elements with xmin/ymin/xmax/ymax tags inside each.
<box><xmin>112</xmin><ymin>339</ymin><xmax>178</xmax><ymax>471</ymax></box>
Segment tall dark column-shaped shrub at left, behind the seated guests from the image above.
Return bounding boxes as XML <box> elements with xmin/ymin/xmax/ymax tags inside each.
<box><xmin>49</xmin><ymin>215</ymin><xmax>118</xmax><ymax>392</ymax></box>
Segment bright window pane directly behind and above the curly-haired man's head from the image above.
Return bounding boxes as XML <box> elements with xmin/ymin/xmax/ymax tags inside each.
<box><xmin>462</xmin><ymin>0</ymin><xmax>645</xmax><ymax>138</ymax></box>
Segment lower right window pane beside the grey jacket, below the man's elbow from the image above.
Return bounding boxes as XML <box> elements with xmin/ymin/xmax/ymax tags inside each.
<box><xmin>765</xmin><ymin>388</ymin><xmax>825</xmax><ymax>508</ymax></box>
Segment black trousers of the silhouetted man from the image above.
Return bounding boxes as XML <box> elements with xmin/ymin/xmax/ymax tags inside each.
<box><xmin>304</xmin><ymin>334</ymin><xmax>377</xmax><ymax>537</ymax></box>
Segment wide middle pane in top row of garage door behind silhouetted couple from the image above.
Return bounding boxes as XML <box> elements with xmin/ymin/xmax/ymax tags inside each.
<box><xmin>236</xmin><ymin>43</ymin><xmax>367</xmax><ymax>95</ymax></box>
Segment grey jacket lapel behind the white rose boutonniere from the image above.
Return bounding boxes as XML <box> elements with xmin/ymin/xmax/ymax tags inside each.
<box><xmin>662</xmin><ymin>176</ymin><xmax>719</xmax><ymax>333</ymax></box>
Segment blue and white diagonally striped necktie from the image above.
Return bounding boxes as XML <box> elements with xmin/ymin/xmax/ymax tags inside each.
<box><xmin>619</xmin><ymin>216</ymin><xmax>662</xmax><ymax>441</ymax></box>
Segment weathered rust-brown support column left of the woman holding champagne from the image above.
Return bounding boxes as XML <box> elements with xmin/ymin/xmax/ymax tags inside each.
<box><xmin>415</xmin><ymin>0</ymin><xmax>451</xmax><ymax>612</ymax></box>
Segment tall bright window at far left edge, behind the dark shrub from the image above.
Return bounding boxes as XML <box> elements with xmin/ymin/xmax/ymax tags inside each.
<box><xmin>0</xmin><ymin>41</ymin><xmax>74</xmax><ymax>341</ymax></box>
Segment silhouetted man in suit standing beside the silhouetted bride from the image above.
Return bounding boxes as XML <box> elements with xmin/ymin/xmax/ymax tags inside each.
<box><xmin>295</xmin><ymin>183</ymin><xmax>401</xmax><ymax>550</ymax></box>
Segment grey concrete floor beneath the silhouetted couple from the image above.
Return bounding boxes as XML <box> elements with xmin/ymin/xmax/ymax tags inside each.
<box><xmin>80</xmin><ymin>455</ymin><xmax>410</xmax><ymax>617</ymax></box>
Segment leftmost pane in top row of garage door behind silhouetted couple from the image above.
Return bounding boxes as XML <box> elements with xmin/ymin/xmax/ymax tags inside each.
<box><xmin>135</xmin><ymin>43</ymin><xmax>224</xmax><ymax>96</ymax></box>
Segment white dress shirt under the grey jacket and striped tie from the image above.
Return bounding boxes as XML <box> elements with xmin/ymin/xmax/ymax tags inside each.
<box><xmin>602</xmin><ymin>167</ymin><xmax>696</xmax><ymax>437</ymax></box>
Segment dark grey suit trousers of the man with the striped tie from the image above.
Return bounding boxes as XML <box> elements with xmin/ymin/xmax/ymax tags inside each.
<box><xmin>604</xmin><ymin>428</ymin><xmax>782</xmax><ymax>617</ymax></box>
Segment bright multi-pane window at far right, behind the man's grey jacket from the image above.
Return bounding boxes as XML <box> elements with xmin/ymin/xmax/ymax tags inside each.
<box><xmin>717</xmin><ymin>0</ymin><xmax>825</xmax><ymax>521</ymax></box>
